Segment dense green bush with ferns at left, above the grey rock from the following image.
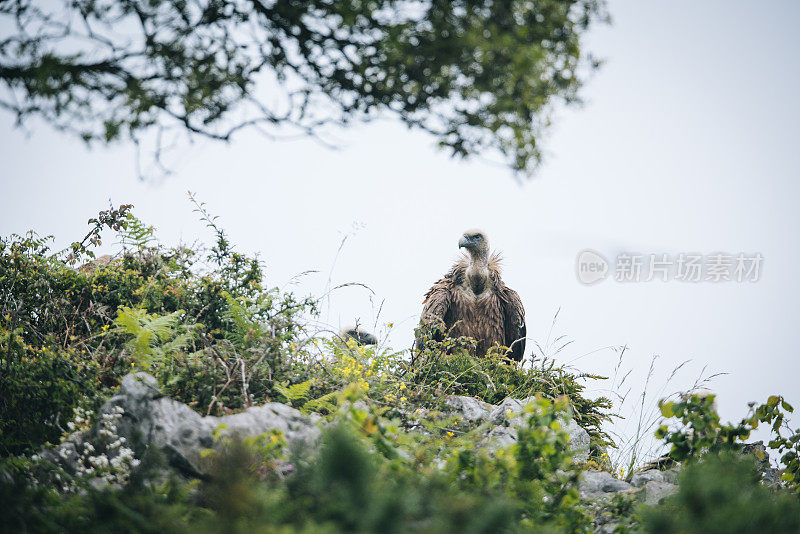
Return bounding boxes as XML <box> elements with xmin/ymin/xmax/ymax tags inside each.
<box><xmin>0</xmin><ymin>206</ymin><xmax>314</xmax><ymax>455</ymax></box>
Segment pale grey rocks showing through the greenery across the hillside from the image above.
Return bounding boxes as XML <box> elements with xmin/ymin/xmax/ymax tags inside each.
<box><xmin>40</xmin><ymin>373</ymin><xmax>780</xmax><ymax>533</ymax></box>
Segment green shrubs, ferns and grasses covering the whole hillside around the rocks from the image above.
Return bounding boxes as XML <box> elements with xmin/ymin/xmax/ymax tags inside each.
<box><xmin>0</xmin><ymin>203</ymin><xmax>800</xmax><ymax>533</ymax></box>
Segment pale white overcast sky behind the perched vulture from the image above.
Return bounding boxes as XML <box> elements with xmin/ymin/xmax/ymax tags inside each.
<box><xmin>0</xmin><ymin>0</ymin><xmax>800</xmax><ymax>460</ymax></box>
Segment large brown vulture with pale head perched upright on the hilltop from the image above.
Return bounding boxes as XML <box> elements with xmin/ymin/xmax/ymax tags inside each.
<box><xmin>421</xmin><ymin>230</ymin><xmax>526</xmax><ymax>361</ymax></box>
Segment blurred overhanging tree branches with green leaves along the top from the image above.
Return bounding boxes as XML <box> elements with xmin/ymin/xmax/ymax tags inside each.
<box><xmin>0</xmin><ymin>0</ymin><xmax>606</xmax><ymax>175</ymax></box>
